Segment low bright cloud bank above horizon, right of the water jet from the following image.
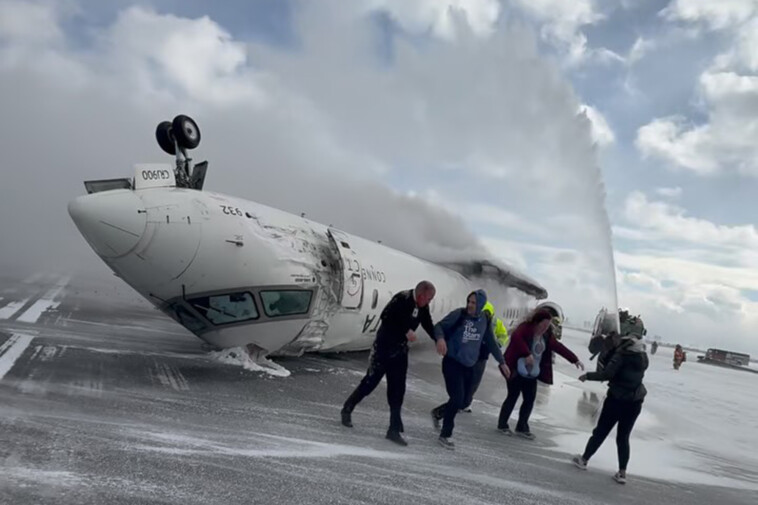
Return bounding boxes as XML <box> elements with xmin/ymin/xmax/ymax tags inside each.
<box><xmin>614</xmin><ymin>192</ymin><xmax>758</xmax><ymax>350</ymax></box>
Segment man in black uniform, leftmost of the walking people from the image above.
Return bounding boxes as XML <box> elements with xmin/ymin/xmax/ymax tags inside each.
<box><xmin>341</xmin><ymin>281</ymin><xmax>436</xmax><ymax>445</ymax></box>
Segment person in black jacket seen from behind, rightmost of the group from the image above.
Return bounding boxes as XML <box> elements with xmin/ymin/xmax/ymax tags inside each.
<box><xmin>572</xmin><ymin>335</ymin><xmax>649</xmax><ymax>484</ymax></box>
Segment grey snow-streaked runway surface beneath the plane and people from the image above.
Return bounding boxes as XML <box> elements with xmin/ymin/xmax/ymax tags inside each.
<box><xmin>0</xmin><ymin>274</ymin><xmax>758</xmax><ymax>505</ymax></box>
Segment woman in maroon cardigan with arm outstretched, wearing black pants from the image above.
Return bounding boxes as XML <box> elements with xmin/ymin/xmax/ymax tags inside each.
<box><xmin>497</xmin><ymin>309</ymin><xmax>584</xmax><ymax>440</ymax></box>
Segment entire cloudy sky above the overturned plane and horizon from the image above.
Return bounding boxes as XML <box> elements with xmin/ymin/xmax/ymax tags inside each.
<box><xmin>0</xmin><ymin>0</ymin><xmax>758</xmax><ymax>353</ymax></box>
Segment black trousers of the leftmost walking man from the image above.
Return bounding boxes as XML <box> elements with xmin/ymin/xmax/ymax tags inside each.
<box><xmin>343</xmin><ymin>349</ymin><xmax>408</xmax><ymax>431</ymax></box>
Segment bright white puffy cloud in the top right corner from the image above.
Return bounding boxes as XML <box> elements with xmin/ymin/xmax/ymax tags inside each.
<box><xmin>636</xmin><ymin>0</ymin><xmax>758</xmax><ymax>177</ymax></box>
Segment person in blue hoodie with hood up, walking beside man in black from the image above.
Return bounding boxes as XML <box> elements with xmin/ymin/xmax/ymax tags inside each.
<box><xmin>432</xmin><ymin>289</ymin><xmax>510</xmax><ymax>449</ymax></box>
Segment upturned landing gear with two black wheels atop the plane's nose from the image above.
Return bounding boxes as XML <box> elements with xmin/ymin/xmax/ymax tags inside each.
<box><xmin>155</xmin><ymin>114</ymin><xmax>208</xmax><ymax>189</ymax></box>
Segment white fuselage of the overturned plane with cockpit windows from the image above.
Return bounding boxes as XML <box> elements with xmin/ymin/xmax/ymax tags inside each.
<box><xmin>69</xmin><ymin>181</ymin><xmax>548</xmax><ymax>354</ymax></box>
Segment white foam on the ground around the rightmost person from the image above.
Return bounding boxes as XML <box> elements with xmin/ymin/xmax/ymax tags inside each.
<box><xmin>535</xmin><ymin>331</ymin><xmax>758</xmax><ymax>489</ymax></box>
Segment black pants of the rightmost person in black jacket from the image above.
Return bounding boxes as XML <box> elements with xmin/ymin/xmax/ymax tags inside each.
<box><xmin>582</xmin><ymin>396</ymin><xmax>642</xmax><ymax>471</ymax></box>
